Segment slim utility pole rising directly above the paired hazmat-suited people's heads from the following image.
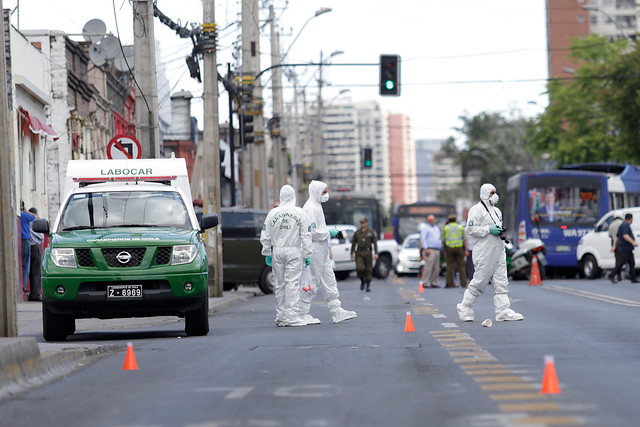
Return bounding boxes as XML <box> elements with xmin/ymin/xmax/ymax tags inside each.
<box><xmin>269</xmin><ymin>5</ymin><xmax>288</xmax><ymax>194</ymax></box>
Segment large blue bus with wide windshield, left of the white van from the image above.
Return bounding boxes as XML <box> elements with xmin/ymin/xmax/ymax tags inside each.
<box><xmin>504</xmin><ymin>170</ymin><xmax>609</xmax><ymax>276</ymax></box>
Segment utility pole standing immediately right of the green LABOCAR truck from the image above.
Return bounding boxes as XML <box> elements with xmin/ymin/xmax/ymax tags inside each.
<box><xmin>202</xmin><ymin>0</ymin><xmax>226</xmax><ymax>297</ymax></box>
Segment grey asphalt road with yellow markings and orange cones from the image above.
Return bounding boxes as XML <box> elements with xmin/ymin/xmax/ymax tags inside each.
<box><xmin>0</xmin><ymin>277</ymin><xmax>640</xmax><ymax>427</ymax></box>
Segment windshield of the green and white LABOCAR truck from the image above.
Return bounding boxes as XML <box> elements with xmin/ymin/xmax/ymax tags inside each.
<box><xmin>59</xmin><ymin>191</ymin><xmax>192</xmax><ymax>231</ymax></box>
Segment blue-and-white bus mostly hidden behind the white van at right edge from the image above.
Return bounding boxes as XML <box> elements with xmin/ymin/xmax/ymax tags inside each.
<box><xmin>560</xmin><ymin>163</ymin><xmax>640</xmax><ymax>210</ymax></box>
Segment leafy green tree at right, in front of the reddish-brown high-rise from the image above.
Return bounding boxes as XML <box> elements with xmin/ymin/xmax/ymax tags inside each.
<box><xmin>529</xmin><ymin>36</ymin><xmax>640</xmax><ymax>165</ymax></box>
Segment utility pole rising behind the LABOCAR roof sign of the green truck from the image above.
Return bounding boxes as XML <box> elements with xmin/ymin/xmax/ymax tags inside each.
<box><xmin>133</xmin><ymin>0</ymin><xmax>160</xmax><ymax>159</ymax></box>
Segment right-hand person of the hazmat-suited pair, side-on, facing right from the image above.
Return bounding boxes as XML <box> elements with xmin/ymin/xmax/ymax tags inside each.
<box><xmin>300</xmin><ymin>181</ymin><xmax>357</xmax><ymax>323</ymax></box>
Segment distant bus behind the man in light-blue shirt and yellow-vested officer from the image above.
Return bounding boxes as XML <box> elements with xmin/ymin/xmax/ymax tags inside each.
<box><xmin>391</xmin><ymin>202</ymin><xmax>456</xmax><ymax>244</ymax></box>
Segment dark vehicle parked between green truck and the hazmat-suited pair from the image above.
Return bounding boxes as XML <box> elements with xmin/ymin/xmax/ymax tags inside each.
<box><xmin>220</xmin><ymin>208</ymin><xmax>273</xmax><ymax>294</ymax></box>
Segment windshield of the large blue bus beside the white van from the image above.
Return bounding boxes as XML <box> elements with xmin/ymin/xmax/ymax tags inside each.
<box><xmin>527</xmin><ymin>177</ymin><xmax>601</xmax><ymax>226</ymax></box>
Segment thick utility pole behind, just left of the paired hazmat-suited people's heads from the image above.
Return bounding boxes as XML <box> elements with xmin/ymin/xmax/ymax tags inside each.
<box><xmin>242</xmin><ymin>0</ymin><xmax>269</xmax><ymax>209</ymax></box>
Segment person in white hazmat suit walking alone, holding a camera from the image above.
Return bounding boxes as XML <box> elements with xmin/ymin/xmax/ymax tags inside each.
<box><xmin>457</xmin><ymin>184</ymin><xmax>524</xmax><ymax>322</ymax></box>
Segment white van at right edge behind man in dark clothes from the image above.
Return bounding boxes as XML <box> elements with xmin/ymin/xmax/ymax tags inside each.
<box><xmin>576</xmin><ymin>207</ymin><xmax>640</xmax><ymax>279</ymax></box>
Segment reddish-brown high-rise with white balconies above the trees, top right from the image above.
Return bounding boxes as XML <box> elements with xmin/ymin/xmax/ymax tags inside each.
<box><xmin>547</xmin><ymin>0</ymin><xmax>640</xmax><ymax>78</ymax></box>
